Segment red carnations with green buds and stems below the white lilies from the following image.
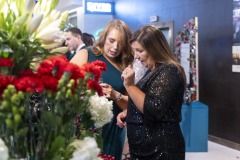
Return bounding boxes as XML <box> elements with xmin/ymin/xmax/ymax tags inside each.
<box><xmin>0</xmin><ymin>56</ymin><xmax>113</xmax><ymax>159</ymax></box>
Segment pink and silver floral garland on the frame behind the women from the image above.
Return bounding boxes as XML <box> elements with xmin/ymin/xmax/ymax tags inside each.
<box><xmin>174</xmin><ymin>18</ymin><xmax>197</xmax><ymax>102</ymax></box>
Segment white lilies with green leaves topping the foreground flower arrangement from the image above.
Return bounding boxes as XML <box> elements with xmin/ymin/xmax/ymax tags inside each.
<box><xmin>0</xmin><ymin>0</ymin><xmax>68</xmax><ymax>74</ymax></box>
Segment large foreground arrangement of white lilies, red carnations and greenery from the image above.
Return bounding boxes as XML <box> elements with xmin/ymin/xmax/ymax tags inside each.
<box><xmin>0</xmin><ymin>0</ymin><xmax>112</xmax><ymax>160</ymax></box>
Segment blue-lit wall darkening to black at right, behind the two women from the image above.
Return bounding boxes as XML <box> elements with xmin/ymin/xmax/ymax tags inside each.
<box><xmin>115</xmin><ymin>0</ymin><xmax>240</xmax><ymax>144</ymax></box>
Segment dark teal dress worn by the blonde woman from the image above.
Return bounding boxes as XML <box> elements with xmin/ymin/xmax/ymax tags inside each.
<box><xmin>87</xmin><ymin>47</ymin><xmax>126</xmax><ymax>160</ymax></box>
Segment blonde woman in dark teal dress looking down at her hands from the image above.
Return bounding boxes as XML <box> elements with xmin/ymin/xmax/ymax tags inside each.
<box><xmin>71</xmin><ymin>19</ymin><xmax>133</xmax><ymax>160</ymax></box>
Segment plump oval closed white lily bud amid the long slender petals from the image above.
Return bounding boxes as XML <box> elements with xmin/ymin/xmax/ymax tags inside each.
<box><xmin>28</xmin><ymin>12</ymin><xmax>43</xmax><ymax>34</ymax></box>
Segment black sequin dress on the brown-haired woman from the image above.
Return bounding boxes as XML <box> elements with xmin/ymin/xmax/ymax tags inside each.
<box><xmin>126</xmin><ymin>64</ymin><xmax>185</xmax><ymax>160</ymax></box>
